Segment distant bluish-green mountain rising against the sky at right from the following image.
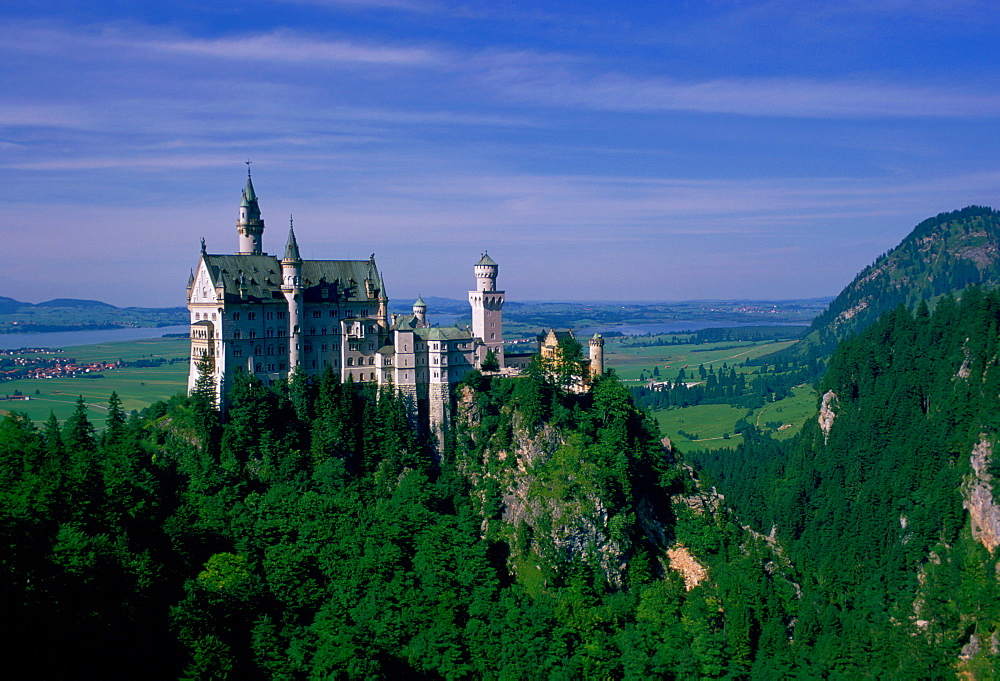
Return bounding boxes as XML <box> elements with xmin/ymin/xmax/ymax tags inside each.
<box><xmin>780</xmin><ymin>206</ymin><xmax>1000</xmax><ymax>357</ymax></box>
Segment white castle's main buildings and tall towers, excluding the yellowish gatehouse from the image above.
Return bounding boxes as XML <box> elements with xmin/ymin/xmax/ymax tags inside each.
<box><xmin>188</xmin><ymin>170</ymin><xmax>505</xmax><ymax>437</ymax></box>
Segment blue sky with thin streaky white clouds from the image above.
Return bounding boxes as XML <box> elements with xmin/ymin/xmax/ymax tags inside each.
<box><xmin>0</xmin><ymin>0</ymin><xmax>1000</xmax><ymax>306</ymax></box>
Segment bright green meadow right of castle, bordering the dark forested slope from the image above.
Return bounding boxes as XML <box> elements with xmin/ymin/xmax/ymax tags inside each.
<box><xmin>653</xmin><ymin>386</ymin><xmax>816</xmax><ymax>453</ymax></box>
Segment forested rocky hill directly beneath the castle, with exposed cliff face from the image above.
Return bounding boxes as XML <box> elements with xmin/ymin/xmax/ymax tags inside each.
<box><xmin>0</xmin><ymin>358</ymin><xmax>796</xmax><ymax>679</ymax></box>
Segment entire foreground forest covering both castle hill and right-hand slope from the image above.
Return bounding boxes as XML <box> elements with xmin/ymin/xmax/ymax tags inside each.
<box><xmin>0</xmin><ymin>287</ymin><xmax>1000</xmax><ymax>679</ymax></box>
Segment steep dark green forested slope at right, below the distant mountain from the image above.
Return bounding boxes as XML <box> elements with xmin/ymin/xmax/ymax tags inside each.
<box><xmin>698</xmin><ymin>287</ymin><xmax>1000</xmax><ymax>678</ymax></box>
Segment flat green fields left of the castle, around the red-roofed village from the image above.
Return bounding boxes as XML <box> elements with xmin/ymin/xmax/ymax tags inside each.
<box><xmin>0</xmin><ymin>338</ymin><xmax>190</xmax><ymax>429</ymax></box>
